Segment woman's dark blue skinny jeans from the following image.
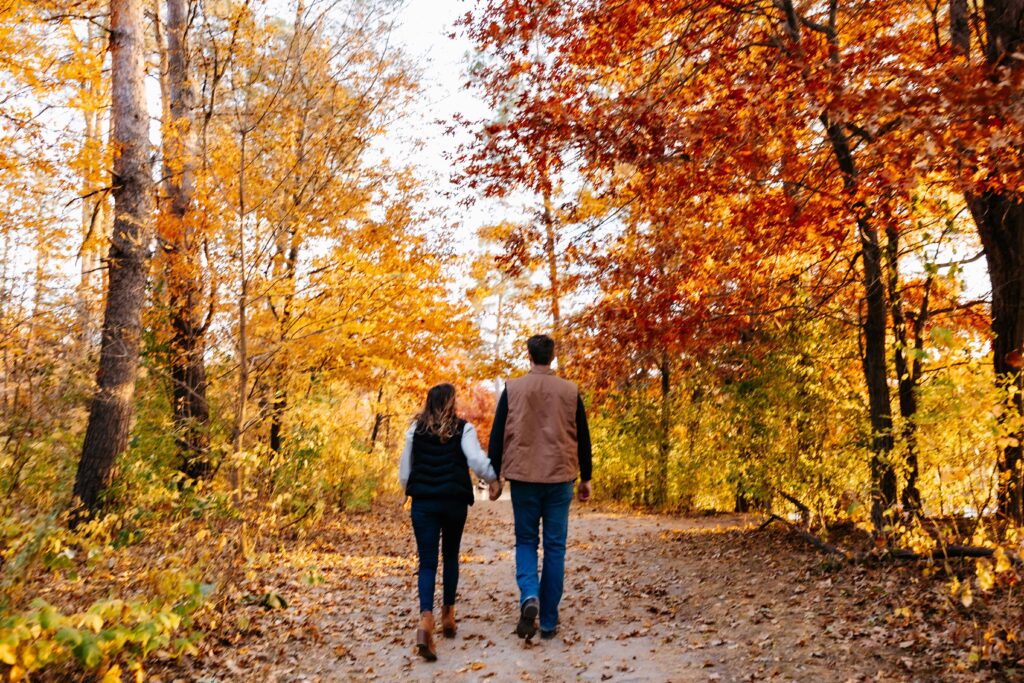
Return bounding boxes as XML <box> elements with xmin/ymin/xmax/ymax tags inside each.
<box><xmin>410</xmin><ymin>498</ymin><xmax>469</xmax><ymax>612</ymax></box>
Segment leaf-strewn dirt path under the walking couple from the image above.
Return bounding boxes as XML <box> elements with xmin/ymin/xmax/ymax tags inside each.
<box><xmin>165</xmin><ymin>501</ymin><xmax>958</xmax><ymax>683</ymax></box>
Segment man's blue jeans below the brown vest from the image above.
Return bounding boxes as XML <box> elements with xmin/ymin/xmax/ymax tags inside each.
<box><xmin>510</xmin><ymin>481</ymin><xmax>573</xmax><ymax>631</ymax></box>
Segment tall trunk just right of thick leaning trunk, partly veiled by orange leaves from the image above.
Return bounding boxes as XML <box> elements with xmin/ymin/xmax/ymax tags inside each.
<box><xmin>158</xmin><ymin>0</ymin><xmax>211</xmax><ymax>479</ymax></box>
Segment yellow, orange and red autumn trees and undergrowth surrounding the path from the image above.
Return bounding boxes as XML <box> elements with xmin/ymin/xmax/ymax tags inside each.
<box><xmin>0</xmin><ymin>0</ymin><xmax>1024</xmax><ymax>680</ymax></box>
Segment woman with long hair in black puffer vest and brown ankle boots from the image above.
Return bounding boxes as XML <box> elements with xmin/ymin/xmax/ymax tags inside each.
<box><xmin>398</xmin><ymin>384</ymin><xmax>497</xmax><ymax>661</ymax></box>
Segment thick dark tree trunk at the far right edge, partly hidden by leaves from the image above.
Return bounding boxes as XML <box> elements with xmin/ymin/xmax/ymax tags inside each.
<box><xmin>950</xmin><ymin>0</ymin><xmax>1024</xmax><ymax>523</ymax></box>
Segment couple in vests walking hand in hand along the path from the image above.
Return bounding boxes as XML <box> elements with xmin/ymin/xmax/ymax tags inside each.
<box><xmin>398</xmin><ymin>335</ymin><xmax>591</xmax><ymax>661</ymax></box>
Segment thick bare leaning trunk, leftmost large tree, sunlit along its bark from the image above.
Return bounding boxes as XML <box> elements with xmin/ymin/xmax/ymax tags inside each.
<box><xmin>74</xmin><ymin>0</ymin><xmax>153</xmax><ymax>521</ymax></box>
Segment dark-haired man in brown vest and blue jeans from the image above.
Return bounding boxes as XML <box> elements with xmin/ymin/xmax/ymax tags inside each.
<box><xmin>487</xmin><ymin>335</ymin><xmax>592</xmax><ymax>640</ymax></box>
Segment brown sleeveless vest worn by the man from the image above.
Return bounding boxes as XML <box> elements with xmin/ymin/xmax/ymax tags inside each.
<box><xmin>502</xmin><ymin>366</ymin><xmax>580</xmax><ymax>483</ymax></box>
